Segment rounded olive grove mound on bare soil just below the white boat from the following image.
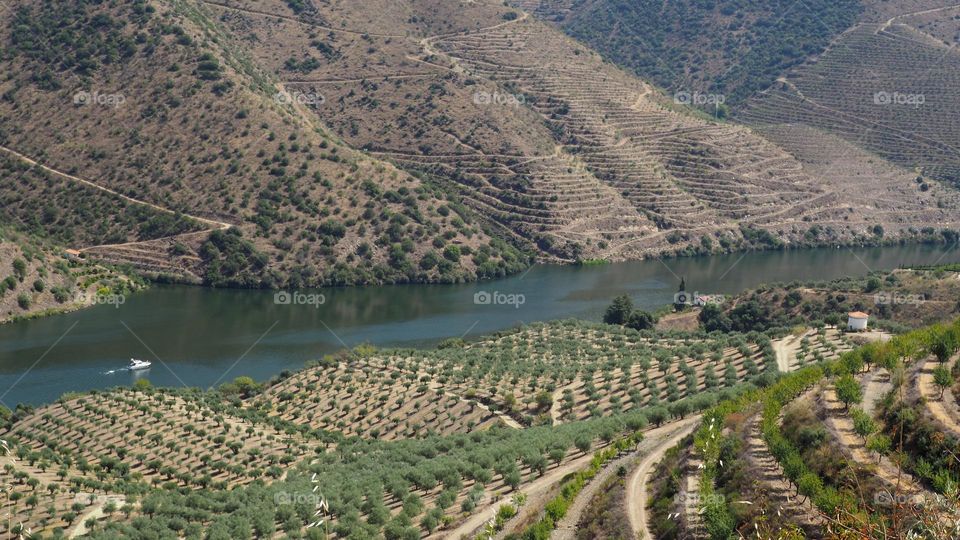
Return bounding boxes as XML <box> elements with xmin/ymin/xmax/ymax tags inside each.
<box><xmin>6</xmin><ymin>390</ymin><xmax>306</xmax><ymax>489</ymax></box>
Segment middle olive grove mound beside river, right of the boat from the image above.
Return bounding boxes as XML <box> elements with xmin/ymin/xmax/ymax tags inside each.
<box><xmin>251</xmin><ymin>321</ymin><xmax>777</xmax><ymax>440</ymax></box>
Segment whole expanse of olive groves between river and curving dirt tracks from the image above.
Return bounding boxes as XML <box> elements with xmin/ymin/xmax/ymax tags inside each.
<box><xmin>2</xmin><ymin>321</ymin><xmax>776</xmax><ymax>538</ymax></box>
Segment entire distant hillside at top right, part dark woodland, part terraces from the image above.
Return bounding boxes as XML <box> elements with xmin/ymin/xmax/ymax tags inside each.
<box><xmin>516</xmin><ymin>0</ymin><xmax>960</xmax><ymax>190</ymax></box>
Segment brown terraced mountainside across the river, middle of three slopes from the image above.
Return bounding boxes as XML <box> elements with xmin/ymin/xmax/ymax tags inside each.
<box><xmin>206</xmin><ymin>0</ymin><xmax>956</xmax><ymax>260</ymax></box>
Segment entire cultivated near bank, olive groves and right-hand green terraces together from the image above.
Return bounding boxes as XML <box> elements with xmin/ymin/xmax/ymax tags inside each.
<box><xmin>0</xmin><ymin>314</ymin><xmax>956</xmax><ymax>538</ymax></box>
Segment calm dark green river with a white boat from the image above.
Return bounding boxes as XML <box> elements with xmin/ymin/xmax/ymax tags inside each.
<box><xmin>0</xmin><ymin>245</ymin><xmax>960</xmax><ymax>408</ymax></box>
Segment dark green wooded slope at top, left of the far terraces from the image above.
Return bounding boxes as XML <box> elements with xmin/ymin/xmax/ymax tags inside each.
<box><xmin>513</xmin><ymin>0</ymin><xmax>862</xmax><ymax>104</ymax></box>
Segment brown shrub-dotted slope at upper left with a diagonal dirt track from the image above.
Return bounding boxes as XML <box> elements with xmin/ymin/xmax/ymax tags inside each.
<box><xmin>0</xmin><ymin>0</ymin><xmax>523</xmax><ymax>286</ymax></box>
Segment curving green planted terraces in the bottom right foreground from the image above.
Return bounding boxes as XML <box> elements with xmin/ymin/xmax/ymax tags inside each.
<box><xmin>676</xmin><ymin>323</ymin><xmax>960</xmax><ymax>538</ymax></box>
